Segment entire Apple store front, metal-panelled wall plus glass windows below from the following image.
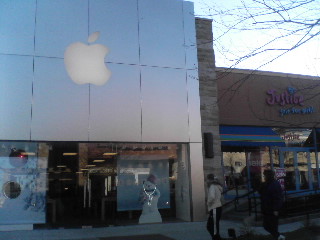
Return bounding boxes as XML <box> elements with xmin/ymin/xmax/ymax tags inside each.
<box><xmin>0</xmin><ymin>0</ymin><xmax>205</xmax><ymax>229</ymax></box>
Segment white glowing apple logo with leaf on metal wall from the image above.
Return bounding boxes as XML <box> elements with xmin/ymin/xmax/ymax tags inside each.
<box><xmin>64</xmin><ymin>32</ymin><xmax>111</xmax><ymax>86</ymax></box>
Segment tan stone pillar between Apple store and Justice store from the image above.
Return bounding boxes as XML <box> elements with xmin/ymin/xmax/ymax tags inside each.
<box><xmin>196</xmin><ymin>18</ymin><xmax>223</xmax><ymax>181</ymax></box>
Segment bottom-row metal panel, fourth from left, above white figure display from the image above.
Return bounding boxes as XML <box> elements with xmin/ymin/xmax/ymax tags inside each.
<box><xmin>141</xmin><ymin>67</ymin><xmax>189</xmax><ymax>142</ymax></box>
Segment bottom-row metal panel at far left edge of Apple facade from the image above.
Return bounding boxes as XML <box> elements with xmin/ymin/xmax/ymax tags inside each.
<box><xmin>0</xmin><ymin>54</ymin><xmax>33</xmax><ymax>140</ymax></box>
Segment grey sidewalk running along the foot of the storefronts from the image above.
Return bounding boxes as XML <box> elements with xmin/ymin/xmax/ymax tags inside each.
<box><xmin>0</xmin><ymin>219</ymin><xmax>312</xmax><ymax>240</ymax></box>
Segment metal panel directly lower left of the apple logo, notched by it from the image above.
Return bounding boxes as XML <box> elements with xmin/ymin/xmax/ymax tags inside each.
<box><xmin>31</xmin><ymin>57</ymin><xmax>89</xmax><ymax>141</ymax></box>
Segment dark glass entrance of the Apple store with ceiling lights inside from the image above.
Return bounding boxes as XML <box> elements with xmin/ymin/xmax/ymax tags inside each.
<box><xmin>47</xmin><ymin>143</ymin><xmax>117</xmax><ymax>227</ymax></box>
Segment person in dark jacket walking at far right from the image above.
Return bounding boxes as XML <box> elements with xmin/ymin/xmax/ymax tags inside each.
<box><xmin>259</xmin><ymin>169</ymin><xmax>285</xmax><ymax>240</ymax></box>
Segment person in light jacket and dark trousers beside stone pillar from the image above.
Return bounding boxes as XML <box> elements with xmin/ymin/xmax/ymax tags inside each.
<box><xmin>207</xmin><ymin>174</ymin><xmax>223</xmax><ymax>240</ymax></box>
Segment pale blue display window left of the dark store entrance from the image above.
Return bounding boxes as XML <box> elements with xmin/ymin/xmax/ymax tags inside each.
<box><xmin>0</xmin><ymin>142</ymin><xmax>47</xmax><ymax>224</ymax></box>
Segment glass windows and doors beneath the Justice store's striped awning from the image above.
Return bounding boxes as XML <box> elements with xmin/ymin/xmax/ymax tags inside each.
<box><xmin>223</xmin><ymin>128</ymin><xmax>319</xmax><ymax>195</ymax></box>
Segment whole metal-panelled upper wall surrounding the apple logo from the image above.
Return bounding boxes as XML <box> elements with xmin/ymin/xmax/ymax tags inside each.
<box><xmin>0</xmin><ymin>0</ymin><xmax>201</xmax><ymax>142</ymax></box>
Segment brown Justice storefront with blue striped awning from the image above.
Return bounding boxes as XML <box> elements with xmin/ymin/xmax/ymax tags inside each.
<box><xmin>216</xmin><ymin>68</ymin><xmax>320</xmax><ymax>195</ymax></box>
